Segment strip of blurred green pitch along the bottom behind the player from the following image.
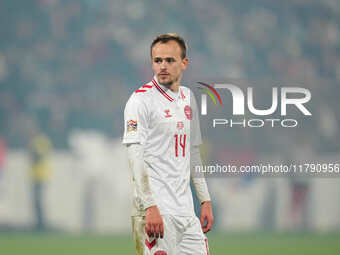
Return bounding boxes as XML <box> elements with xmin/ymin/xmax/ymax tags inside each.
<box><xmin>0</xmin><ymin>232</ymin><xmax>340</xmax><ymax>255</ymax></box>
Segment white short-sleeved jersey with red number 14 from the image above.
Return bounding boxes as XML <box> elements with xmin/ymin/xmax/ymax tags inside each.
<box><xmin>123</xmin><ymin>77</ymin><xmax>201</xmax><ymax>216</ymax></box>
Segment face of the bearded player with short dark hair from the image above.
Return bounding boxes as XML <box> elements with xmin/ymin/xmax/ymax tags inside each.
<box><xmin>151</xmin><ymin>41</ymin><xmax>188</xmax><ymax>87</ymax></box>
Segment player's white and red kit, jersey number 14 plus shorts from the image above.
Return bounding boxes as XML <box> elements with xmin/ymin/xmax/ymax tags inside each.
<box><xmin>123</xmin><ymin>77</ymin><xmax>210</xmax><ymax>255</ymax></box>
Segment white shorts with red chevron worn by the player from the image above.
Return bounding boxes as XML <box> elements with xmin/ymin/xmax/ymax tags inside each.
<box><xmin>132</xmin><ymin>215</ymin><xmax>209</xmax><ymax>255</ymax></box>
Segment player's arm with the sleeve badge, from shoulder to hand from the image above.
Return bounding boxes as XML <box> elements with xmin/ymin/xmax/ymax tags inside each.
<box><xmin>123</xmin><ymin>97</ymin><xmax>164</xmax><ymax>238</ymax></box>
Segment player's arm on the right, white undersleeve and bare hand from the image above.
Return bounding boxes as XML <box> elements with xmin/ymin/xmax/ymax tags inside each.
<box><xmin>190</xmin><ymin>146</ymin><xmax>214</xmax><ymax>233</ymax></box>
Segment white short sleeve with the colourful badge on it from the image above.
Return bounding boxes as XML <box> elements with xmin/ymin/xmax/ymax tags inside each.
<box><xmin>122</xmin><ymin>96</ymin><xmax>148</xmax><ymax>144</ymax></box>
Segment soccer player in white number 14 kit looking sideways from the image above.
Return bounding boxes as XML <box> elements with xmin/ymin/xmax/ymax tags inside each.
<box><xmin>123</xmin><ymin>34</ymin><xmax>214</xmax><ymax>255</ymax></box>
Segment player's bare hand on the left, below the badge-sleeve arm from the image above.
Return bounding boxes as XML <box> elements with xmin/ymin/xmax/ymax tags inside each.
<box><xmin>145</xmin><ymin>205</ymin><xmax>164</xmax><ymax>238</ymax></box>
